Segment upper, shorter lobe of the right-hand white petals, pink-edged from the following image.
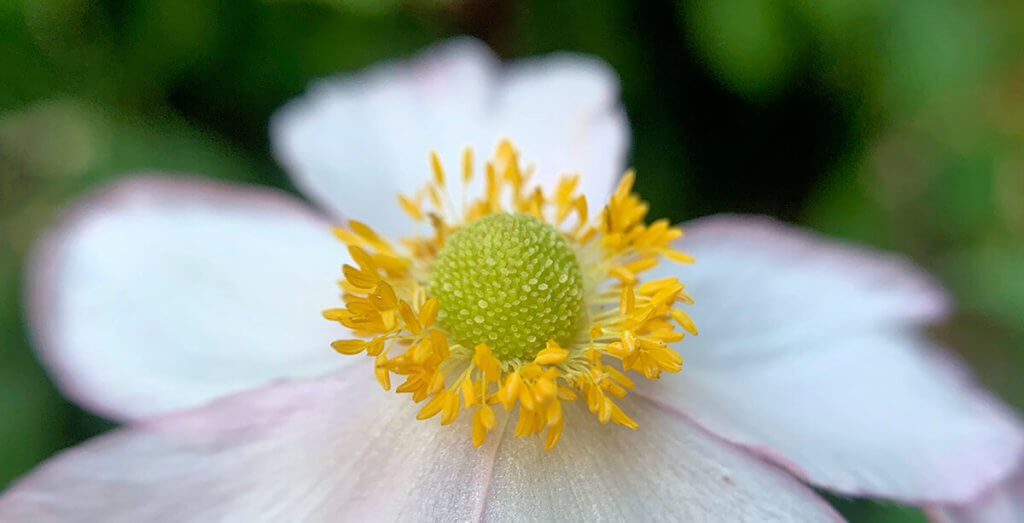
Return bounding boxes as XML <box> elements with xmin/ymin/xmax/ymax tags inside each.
<box><xmin>679</xmin><ymin>216</ymin><xmax>950</xmax><ymax>366</ymax></box>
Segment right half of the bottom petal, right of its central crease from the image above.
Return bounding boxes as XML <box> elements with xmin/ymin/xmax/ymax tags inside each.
<box><xmin>484</xmin><ymin>399</ymin><xmax>842</xmax><ymax>522</ymax></box>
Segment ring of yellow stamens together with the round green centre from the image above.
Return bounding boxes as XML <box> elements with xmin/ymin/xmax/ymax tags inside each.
<box><xmin>324</xmin><ymin>141</ymin><xmax>697</xmax><ymax>449</ymax></box>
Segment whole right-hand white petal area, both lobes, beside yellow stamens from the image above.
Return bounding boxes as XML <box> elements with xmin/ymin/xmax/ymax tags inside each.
<box><xmin>639</xmin><ymin>214</ymin><xmax>1022</xmax><ymax>503</ymax></box>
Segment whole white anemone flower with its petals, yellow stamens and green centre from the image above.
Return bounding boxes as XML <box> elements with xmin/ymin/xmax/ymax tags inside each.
<box><xmin>0</xmin><ymin>40</ymin><xmax>1022</xmax><ymax>522</ymax></box>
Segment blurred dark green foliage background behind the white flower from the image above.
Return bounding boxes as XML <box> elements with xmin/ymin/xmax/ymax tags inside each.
<box><xmin>0</xmin><ymin>0</ymin><xmax>1024</xmax><ymax>522</ymax></box>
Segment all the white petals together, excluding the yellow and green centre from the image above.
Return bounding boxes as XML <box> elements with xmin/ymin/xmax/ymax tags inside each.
<box><xmin>0</xmin><ymin>40</ymin><xmax>1024</xmax><ymax>521</ymax></box>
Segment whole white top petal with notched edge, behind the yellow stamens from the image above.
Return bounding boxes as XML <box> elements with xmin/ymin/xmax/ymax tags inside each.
<box><xmin>271</xmin><ymin>38</ymin><xmax>629</xmax><ymax>235</ymax></box>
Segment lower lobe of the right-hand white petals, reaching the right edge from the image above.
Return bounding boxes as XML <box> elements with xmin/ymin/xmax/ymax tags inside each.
<box><xmin>644</xmin><ymin>333</ymin><xmax>1022</xmax><ymax>504</ymax></box>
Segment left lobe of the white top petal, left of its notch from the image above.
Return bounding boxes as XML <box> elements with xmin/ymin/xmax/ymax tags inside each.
<box><xmin>270</xmin><ymin>39</ymin><xmax>500</xmax><ymax>235</ymax></box>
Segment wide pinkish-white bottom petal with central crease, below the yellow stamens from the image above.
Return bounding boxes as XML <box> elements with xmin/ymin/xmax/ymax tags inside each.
<box><xmin>0</xmin><ymin>367</ymin><xmax>837</xmax><ymax>523</ymax></box>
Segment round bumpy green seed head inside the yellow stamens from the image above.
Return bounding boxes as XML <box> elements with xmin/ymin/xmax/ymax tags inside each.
<box><xmin>430</xmin><ymin>214</ymin><xmax>584</xmax><ymax>359</ymax></box>
